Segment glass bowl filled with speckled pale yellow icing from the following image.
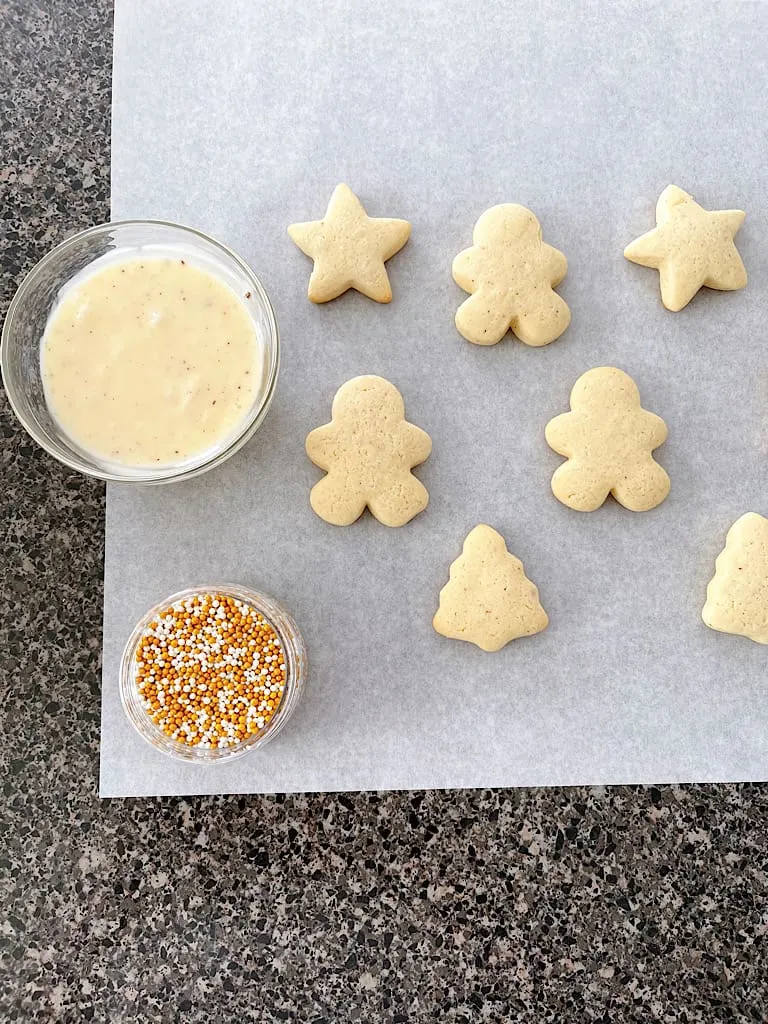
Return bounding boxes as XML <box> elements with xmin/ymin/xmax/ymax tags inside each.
<box><xmin>2</xmin><ymin>221</ymin><xmax>279</xmax><ymax>482</ymax></box>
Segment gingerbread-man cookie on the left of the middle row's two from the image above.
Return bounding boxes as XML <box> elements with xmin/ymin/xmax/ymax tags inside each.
<box><xmin>306</xmin><ymin>377</ymin><xmax>432</xmax><ymax>526</ymax></box>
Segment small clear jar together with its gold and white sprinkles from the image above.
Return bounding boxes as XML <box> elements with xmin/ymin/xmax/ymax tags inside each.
<box><xmin>120</xmin><ymin>585</ymin><xmax>307</xmax><ymax>764</ymax></box>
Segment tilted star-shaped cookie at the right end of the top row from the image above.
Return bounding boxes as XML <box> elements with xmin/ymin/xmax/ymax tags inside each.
<box><xmin>624</xmin><ymin>185</ymin><xmax>746</xmax><ymax>312</ymax></box>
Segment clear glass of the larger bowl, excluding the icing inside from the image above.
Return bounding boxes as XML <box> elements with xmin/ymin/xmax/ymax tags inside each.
<box><xmin>0</xmin><ymin>220</ymin><xmax>280</xmax><ymax>483</ymax></box>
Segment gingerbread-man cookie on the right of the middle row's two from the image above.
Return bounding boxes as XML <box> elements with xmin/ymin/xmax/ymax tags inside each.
<box><xmin>546</xmin><ymin>367</ymin><xmax>670</xmax><ymax>512</ymax></box>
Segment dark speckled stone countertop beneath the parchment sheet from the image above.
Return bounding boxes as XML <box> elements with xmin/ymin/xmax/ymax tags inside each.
<box><xmin>0</xmin><ymin>0</ymin><xmax>768</xmax><ymax>1024</ymax></box>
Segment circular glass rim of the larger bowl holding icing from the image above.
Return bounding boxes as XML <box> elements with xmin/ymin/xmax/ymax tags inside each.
<box><xmin>0</xmin><ymin>218</ymin><xmax>281</xmax><ymax>484</ymax></box>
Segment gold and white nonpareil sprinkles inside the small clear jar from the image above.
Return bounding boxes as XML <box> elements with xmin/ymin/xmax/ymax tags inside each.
<box><xmin>136</xmin><ymin>594</ymin><xmax>286</xmax><ymax>748</ymax></box>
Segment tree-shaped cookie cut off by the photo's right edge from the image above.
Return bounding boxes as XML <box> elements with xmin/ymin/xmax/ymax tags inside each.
<box><xmin>701</xmin><ymin>512</ymin><xmax>768</xmax><ymax>643</ymax></box>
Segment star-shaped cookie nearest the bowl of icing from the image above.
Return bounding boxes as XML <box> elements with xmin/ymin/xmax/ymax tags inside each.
<box><xmin>288</xmin><ymin>184</ymin><xmax>411</xmax><ymax>302</ymax></box>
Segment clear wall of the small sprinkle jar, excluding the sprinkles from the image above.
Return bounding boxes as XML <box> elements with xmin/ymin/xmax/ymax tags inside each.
<box><xmin>120</xmin><ymin>584</ymin><xmax>307</xmax><ymax>765</ymax></box>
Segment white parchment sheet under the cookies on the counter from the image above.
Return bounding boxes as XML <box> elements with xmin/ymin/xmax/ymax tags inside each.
<box><xmin>101</xmin><ymin>0</ymin><xmax>768</xmax><ymax>796</ymax></box>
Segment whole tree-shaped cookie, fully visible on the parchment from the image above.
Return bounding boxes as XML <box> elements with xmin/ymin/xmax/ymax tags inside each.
<box><xmin>432</xmin><ymin>523</ymin><xmax>549</xmax><ymax>650</ymax></box>
